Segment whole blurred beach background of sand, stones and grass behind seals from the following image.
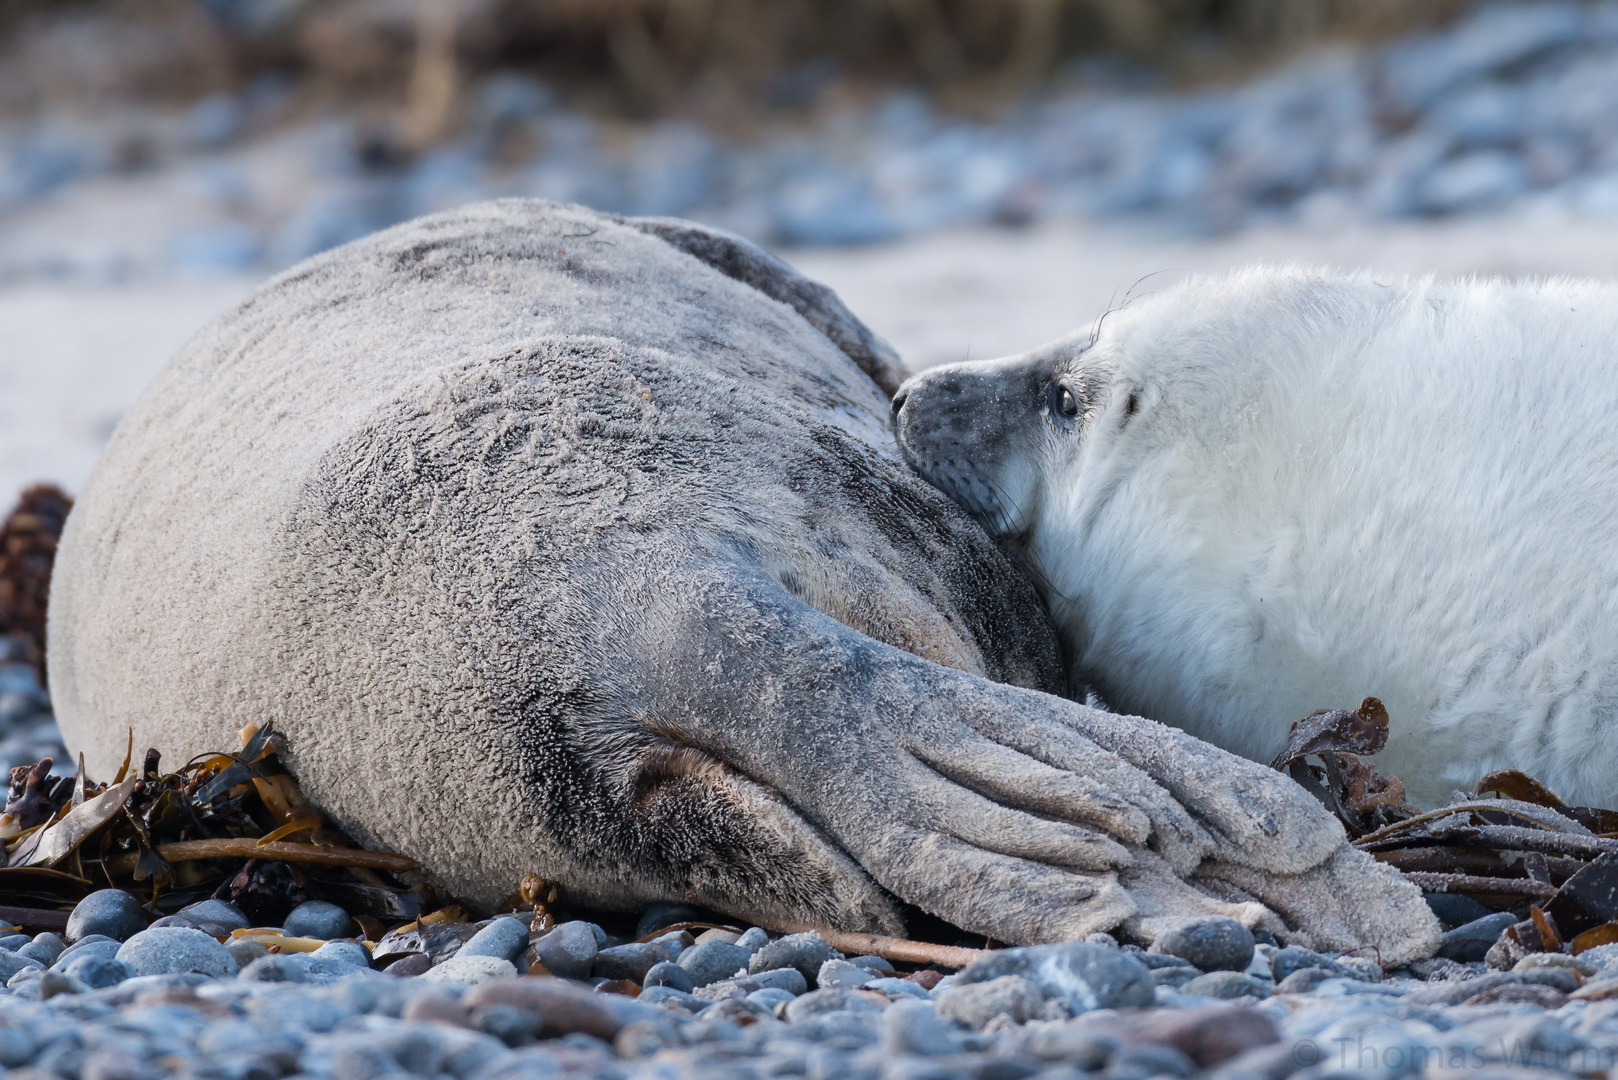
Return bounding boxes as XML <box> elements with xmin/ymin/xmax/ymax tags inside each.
<box><xmin>9</xmin><ymin>0</ymin><xmax>1618</xmax><ymax>489</ymax></box>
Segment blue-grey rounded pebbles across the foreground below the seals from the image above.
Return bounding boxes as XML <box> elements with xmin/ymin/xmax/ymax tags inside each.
<box><xmin>9</xmin><ymin>891</ymin><xmax>1618</xmax><ymax>1080</ymax></box>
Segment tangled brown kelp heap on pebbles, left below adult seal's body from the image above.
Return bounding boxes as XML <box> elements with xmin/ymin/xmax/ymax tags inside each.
<box><xmin>0</xmin><ymin>725</ymin><xmax>438</xmax><ymax>926</ymax></box>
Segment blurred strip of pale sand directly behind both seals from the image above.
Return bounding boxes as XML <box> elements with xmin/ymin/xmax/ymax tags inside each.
<box><xmin>0</xmin><ymin>212</ymin><xmax>1618</xmax><ymax>502</ymax></box>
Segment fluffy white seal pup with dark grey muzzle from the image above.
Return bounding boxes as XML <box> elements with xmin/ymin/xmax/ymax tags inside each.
<box><xmin>895</xmin><ymin>269</ymin><xmax>1618</xmax><ymax>806</ymax></box>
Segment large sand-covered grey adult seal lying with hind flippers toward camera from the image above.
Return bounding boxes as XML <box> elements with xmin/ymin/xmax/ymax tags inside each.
<box><xmin>49</xmin><ymin>201</ymin><xmax>1435</xmax><ymax>959</ymax></box>
